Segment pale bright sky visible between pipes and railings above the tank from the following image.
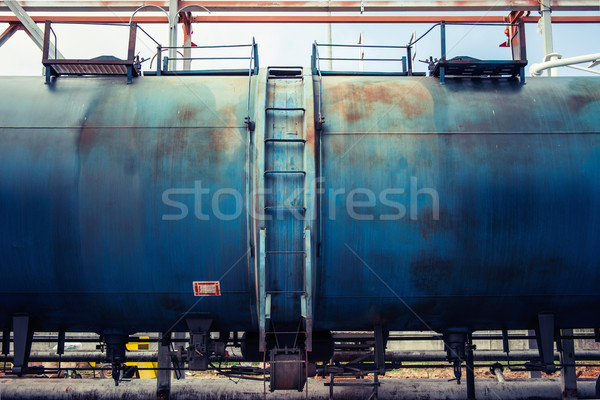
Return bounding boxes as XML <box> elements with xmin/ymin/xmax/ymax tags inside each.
<box><xmin>0</xmin><ymin>11</ymin><xmax>600</xmax><ymax>76</ymax></box>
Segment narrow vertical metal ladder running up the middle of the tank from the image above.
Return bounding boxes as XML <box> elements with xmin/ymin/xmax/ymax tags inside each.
<box><xmin>258</xmin><ymin>67</ymin><xmax>312</xmax><ymax>360</ymax></box>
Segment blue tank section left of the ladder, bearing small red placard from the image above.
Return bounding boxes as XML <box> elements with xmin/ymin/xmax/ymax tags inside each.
<box><xmin>0</xmin><ymin>77</ymin><xmax>251</xmax><ymax>332</ymax></box>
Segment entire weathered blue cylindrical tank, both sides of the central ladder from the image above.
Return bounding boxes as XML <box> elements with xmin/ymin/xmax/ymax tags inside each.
<box><xmin>0</xmin><ymin>73</ymin><xmax>600</xmax><ymax>333</ymax></box>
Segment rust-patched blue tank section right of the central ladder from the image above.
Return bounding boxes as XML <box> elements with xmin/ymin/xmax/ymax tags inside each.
<box><xmin>315</xmin><ymin>76</ymin><xmax>600</xmax><ymax>331</ymax></box>
